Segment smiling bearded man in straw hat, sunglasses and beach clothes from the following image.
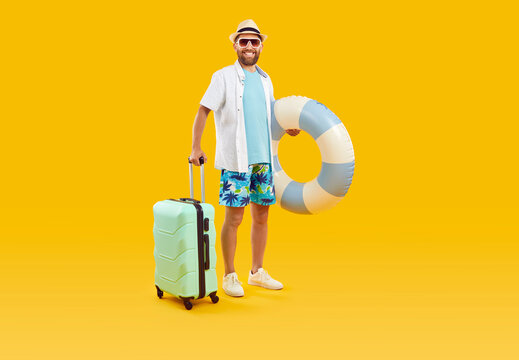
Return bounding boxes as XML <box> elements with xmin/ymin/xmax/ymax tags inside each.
<box><xmin>190</xmin><ymin>20</ymin><xmax>299</xmax><ymax>296</ymax></box>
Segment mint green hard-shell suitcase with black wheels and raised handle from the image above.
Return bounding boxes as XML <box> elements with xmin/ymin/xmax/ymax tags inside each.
<box><xmin>153</xmin><ymin>158</ymin><xmax>218</xmax><ymax>310</ymax></box>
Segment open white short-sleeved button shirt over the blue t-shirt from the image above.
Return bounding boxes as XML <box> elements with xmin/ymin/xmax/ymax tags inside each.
<box><xmin>200</xmin><ymin>60</ymin><xmax>275</xmax><ymax>172</ymax></box>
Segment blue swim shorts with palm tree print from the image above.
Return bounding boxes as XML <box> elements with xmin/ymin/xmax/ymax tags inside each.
<box><xmin>219</xmin><ymin>163</ymin><xmax>276</xmax><ymax>207</ymax></box>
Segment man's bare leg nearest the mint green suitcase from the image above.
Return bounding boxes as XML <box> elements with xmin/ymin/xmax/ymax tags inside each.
<box><xmin>221</xmin><ymin>206</ymin><xmax>244</xmax><ymax>275</ymax></box>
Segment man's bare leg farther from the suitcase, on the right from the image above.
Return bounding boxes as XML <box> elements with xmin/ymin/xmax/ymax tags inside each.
<box><xmin>250</xmin><ymin>202</ymin><xmax>269</xmax><ymax>274</ymax></box>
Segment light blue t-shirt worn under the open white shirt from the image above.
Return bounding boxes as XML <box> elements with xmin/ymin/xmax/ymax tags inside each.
<box><xmin>243</xmin><ymin>69</ymin><xmax>270</xmax><ymax>165</ymax></box>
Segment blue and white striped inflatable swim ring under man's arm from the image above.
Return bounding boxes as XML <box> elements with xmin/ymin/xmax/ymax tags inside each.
<box><xmin>271</xmin><ymin>96</ymin><xmax>355</xmax><ymax>214</ymax></box>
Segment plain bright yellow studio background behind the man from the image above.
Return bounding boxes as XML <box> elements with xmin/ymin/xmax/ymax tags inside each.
<box><xmin>0</xmin><ymin>0</ymin><xmax>519</xmax><ymax>359</ymax></box>
